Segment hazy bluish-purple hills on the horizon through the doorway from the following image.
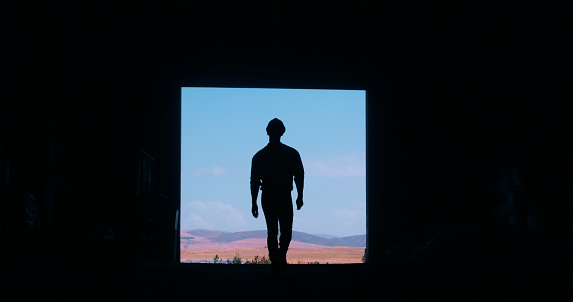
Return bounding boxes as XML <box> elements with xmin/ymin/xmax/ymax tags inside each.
<box><xmin>181</xmin><ymin>229</ymin><xmax>366</xmax><ymax>249</ymax></box>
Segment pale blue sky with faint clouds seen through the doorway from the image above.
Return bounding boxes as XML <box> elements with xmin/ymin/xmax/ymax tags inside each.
<box><xmin>181</xmin><ymin>87</ymin><xmax>366</xmax><ymax>236</ymax></box>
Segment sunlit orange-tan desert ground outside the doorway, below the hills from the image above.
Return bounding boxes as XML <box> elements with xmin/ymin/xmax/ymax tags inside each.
<box><xmin>181</xmin><ymin>247</ymin><xmax>364</xmax><ymax>264</ymax></box>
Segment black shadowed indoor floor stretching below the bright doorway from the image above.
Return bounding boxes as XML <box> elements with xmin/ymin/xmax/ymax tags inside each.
<box><xmin>0</xmin><ymin>263</ymin><xmax>573</xmax><ymax>301</ymax></box>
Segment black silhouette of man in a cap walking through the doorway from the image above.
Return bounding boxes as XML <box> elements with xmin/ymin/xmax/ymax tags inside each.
<box><xmin>251</xmin><ymin>118</ymin><xmax>304</xmax><ymax>273</ymax></box>
